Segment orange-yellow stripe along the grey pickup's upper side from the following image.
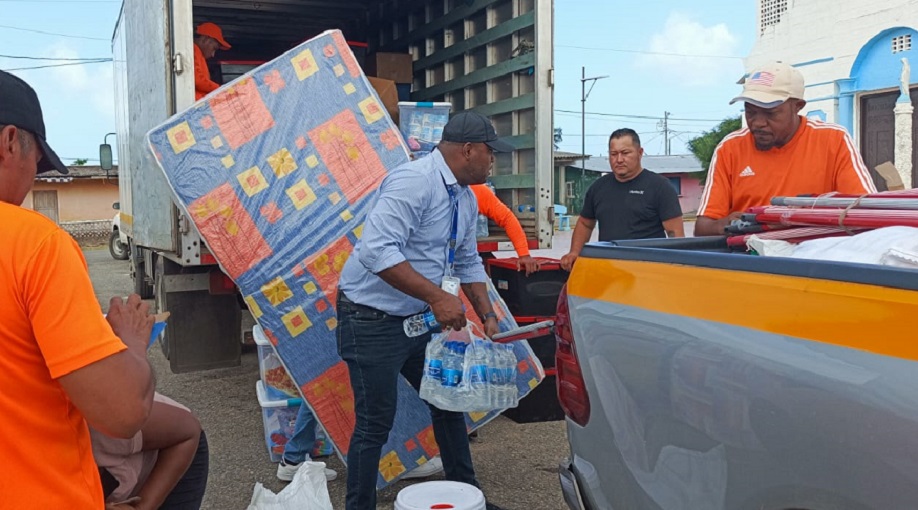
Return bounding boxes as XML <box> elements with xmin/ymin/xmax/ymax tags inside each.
<box><xmin>568</xmin><ymin>258</ymin><xmax>918</xmax><ymax>360</ymax></box>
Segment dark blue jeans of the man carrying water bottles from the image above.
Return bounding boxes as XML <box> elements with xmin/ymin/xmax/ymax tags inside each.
<box><xmin>337</xmin><ymin>294</ymin><xmax>479</xmax><ymax>510</ymax></box>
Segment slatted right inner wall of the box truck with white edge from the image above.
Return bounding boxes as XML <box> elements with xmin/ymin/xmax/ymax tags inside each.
<box><xmin>380</xmin><ymin>0</ymin><xmax>554</xmax><ymax>248</ymax></box>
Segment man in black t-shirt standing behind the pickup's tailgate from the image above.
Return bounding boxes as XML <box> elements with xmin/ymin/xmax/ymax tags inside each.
<box><xmin>561</xmin><ymin>128</ymin><xmax>685</xmax><ymax>271</ymax></box>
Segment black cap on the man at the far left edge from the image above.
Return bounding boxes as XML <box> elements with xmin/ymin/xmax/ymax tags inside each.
<box><xmin>0</xmin><ymin>71</ymin><xmax>70</xmax><ymax>174</ymax></box>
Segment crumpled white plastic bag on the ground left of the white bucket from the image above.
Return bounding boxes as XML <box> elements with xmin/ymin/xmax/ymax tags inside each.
<box><xmin>248</xmin><ymin>462</ymin><xmax>333</xmax><ymax>510</ymax></box>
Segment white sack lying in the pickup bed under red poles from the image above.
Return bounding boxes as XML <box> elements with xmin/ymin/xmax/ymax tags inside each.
<box><xmin>790</xmin><ymin>227</ymin><xmax>918</xmax><ymax>269</ymax></box>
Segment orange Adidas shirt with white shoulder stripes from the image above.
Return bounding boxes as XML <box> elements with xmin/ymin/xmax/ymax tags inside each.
<box><xmin>698</xmin><ymin>117</ymin><xmax>876</xmax><ymax>219</ymax></box>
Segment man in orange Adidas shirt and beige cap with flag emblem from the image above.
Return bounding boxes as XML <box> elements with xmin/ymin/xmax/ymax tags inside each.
<box><xmin>695</xmin><ymin>62</ymin><xmax>876</xmax><ymax>236</ymax></box>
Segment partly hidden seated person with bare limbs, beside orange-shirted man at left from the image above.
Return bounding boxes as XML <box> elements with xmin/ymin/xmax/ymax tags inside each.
<box><xmin>89</xmin><ymin>393</ymin><xmax>210</xmax><ymax>510</ymax></box>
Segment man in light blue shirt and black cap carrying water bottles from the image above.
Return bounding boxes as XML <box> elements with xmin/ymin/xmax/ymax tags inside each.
<box><xmin>336</xmin><ymin>111</ymin><xmax>512</xmax><ymax>510</ymax></box>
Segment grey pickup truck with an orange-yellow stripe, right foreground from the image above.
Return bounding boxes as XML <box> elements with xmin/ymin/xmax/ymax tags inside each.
<box><xmin>556</xmin><ymin>238</ymin><xmax>918</xmax><ymax>510</ymax></box>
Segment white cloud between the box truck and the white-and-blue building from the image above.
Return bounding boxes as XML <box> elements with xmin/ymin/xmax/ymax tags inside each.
<box><xmin>637</xmin><ymin>11</ymin><xmax>742</xmax><ymax>86</ymax></box>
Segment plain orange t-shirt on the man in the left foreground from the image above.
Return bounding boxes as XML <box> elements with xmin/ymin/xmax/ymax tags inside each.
<box><xmin>0</xmin><ymin>202</ymin><xmax>126</xmax><ymax>510</ymax></box>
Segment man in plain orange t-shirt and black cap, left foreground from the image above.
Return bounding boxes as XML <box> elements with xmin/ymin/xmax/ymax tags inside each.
<box><xmin>0</xmin><ymin>71</ymin><xmax>153</xmax><ymax>510</ymax></box>
